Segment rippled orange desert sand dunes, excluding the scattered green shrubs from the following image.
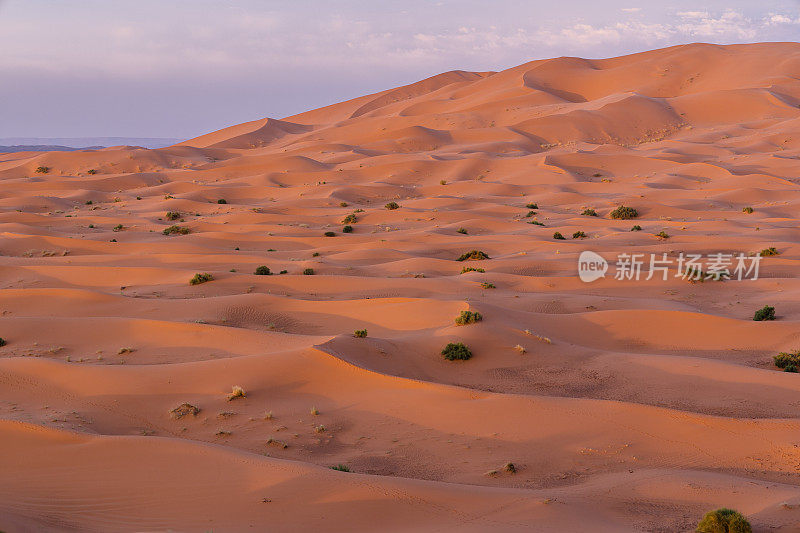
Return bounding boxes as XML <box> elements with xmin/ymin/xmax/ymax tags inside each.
<box><xmin>0</xmin><ymin>43</ymin><xmax>800</xmax><ymax>533</ymax></box>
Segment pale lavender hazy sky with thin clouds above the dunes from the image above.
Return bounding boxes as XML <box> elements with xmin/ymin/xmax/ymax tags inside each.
<box><xmin>0</xmin><ymin>0</ymin><xmax>800</xmax><ymax>138</ymax></box>
